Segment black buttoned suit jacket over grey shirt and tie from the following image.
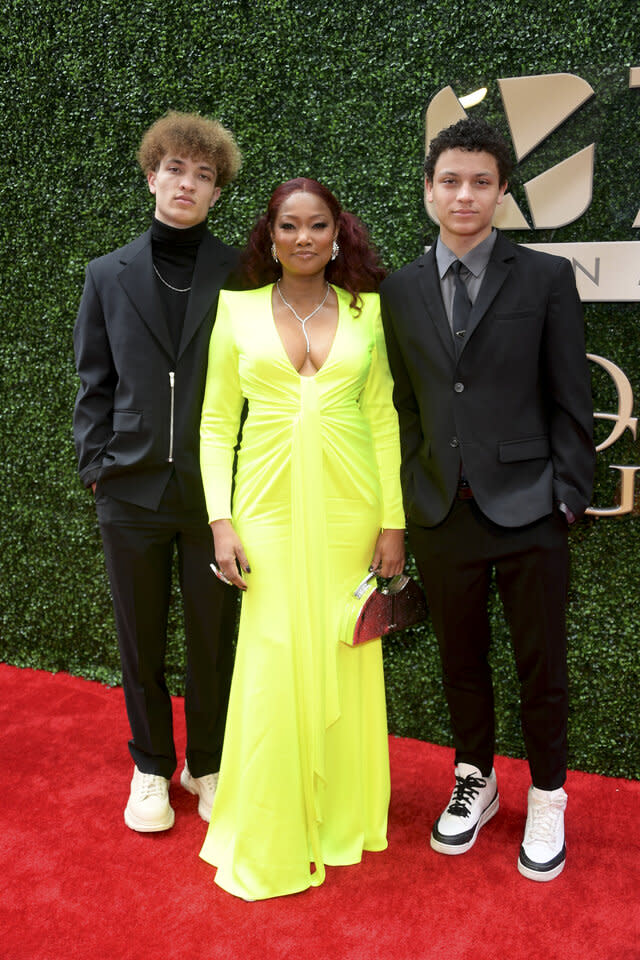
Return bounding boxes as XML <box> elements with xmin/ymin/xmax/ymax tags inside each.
<box><xmin>381</xmin><ymin>234</ymin><xmax>595</xmax><ymax>527</ymax></box>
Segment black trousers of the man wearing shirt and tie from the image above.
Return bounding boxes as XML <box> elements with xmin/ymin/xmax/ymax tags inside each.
<box><xmin>408</xmin><ymin>500</ymin><xmax>569</xmax><ymax>790</ymax></box>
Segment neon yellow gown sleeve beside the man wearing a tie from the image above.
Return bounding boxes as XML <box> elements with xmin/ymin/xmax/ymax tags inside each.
<box><xmin>360</xmin><ymin>306</ymin><xmax>405</xmax><ymax>529</ymax></box>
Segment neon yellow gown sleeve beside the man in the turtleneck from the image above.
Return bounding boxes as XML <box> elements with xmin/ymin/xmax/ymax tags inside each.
<box><xmin>200</xmin><ymin>290</ymin><xmax>243</xmax><ymax>522</ymax></box>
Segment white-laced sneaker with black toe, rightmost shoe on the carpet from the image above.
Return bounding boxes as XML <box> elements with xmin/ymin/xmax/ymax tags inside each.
<box><xmin>518</xmin><ymin>787</ymin><xmax>567</xmax><ymax>881</ymax></box>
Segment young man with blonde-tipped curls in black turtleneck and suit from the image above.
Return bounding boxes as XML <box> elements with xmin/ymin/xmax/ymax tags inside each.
<box><xmin>74</xmin><ymin>112</ymin><xmax>241</xmax><ymax>832</ymax></box>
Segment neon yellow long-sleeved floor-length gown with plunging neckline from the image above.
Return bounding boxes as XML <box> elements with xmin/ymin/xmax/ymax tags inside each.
<box><xmin>200</xmin><ymin>285</ymin><xmax>404</xmax><ymax>900</ymax></box>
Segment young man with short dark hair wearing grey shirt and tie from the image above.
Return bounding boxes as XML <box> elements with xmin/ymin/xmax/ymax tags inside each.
<box><xmin>381</xmin><ymin>119</ymin><xmax>594</xmax><ymax>880</ymax></box>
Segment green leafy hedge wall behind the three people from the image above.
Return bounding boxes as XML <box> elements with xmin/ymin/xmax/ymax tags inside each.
<box><xmin>0</xmin><ymin>0</ymin><xmax>640</xmax><ymax>778</ymax></box>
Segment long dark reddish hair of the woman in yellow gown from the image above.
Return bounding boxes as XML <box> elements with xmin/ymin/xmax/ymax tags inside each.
<box><xmin>242</xmin><ymin>177</ymin><xmax>386</xmax><ymax>312</ymax></box>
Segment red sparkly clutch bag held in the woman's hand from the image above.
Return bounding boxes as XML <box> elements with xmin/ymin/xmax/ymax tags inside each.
<box><xmin>340</xmin><ymin>573</ymin><xmax>427</xmax><ymax>647</ymax></box>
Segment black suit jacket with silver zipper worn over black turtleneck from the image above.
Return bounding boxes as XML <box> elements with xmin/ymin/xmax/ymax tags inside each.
<box><xmin>73</xmin><ymin>230</ymin><xmax>238</xmax><ymax>511</ymax></box>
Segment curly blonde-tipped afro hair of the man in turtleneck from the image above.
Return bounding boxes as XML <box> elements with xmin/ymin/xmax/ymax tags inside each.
<box><xmin>138</xmin><ymin>110</ymin><xmax>242</xmax><ymax>187</ymax></box>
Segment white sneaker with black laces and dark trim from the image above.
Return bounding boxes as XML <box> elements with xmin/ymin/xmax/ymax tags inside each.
<box><xmin>430</xmin><ymin>763</ymin><xmax>500</xmax><ymax>855</ymax></box>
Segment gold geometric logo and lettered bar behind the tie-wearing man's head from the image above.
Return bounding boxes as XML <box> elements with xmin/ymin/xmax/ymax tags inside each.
<box><xmin>425</xmin><ymin>67</ymin><xmax>640</xmax><ymax>302</ymax></box>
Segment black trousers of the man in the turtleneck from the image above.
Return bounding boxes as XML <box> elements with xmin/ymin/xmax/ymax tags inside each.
<box><xmin>96</xmin><ymin>487</ymin><xmax>237</xmax><ymax>779</ymax></box>
